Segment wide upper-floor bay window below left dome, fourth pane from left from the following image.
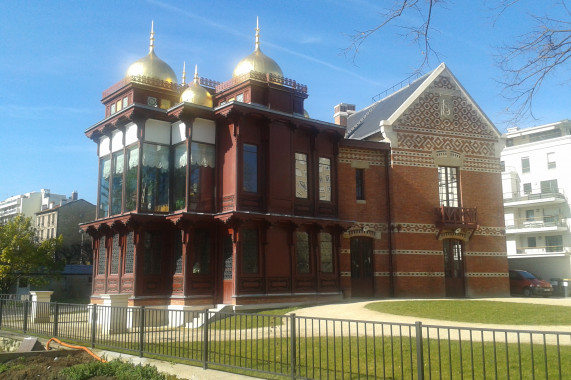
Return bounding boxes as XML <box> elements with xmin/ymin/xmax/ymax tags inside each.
<box><xmin>141</xmin><ymin>144</ymin><xmax>169</xmax><ymax>212</ymax></box>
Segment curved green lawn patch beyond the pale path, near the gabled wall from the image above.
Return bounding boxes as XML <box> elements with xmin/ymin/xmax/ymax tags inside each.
<box><xmin>366</xmin><ymin>300</ymin><xmax>571</xmax><ymax>326</ymax></box>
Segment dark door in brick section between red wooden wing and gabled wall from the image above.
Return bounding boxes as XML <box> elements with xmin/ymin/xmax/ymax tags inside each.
<box><xmin>351</xmin><ymin>237</ymin><xmax>373</xmax><ymax>297</ymax></box>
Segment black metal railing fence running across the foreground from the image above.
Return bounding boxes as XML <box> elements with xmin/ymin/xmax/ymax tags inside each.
<box><xmin>0</xmin><ymin>298</ymin><xmax>571</xmax><ymax>380</ymax></box>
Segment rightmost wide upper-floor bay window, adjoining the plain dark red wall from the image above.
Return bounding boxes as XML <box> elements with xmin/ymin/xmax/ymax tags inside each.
<box><xmin>189</xmin><ymin>142</ymin><xmax>216</xmax><ymax>212</ymax></box>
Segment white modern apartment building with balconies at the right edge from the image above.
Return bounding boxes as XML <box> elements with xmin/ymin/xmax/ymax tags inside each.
<box><xmin>501</xmin><ymin>120</ymin><xmax>571</xmax><ymax>279</ymax></box>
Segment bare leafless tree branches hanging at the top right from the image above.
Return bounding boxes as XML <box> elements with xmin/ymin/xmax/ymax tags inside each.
<box><xmin>345</xmin><ymin>0</ymin><xmax>571</xmax><ymax>123</ymax></box>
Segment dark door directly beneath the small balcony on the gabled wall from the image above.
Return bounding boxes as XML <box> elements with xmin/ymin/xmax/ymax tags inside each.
<box><xmin>444</xmin><ymin>239</ymin><xmax>466</xmax><ymax>297</ymax></box>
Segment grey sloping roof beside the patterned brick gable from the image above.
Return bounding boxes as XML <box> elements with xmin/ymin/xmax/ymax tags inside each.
<box><xmin>346</xmin><ymin>72</ymin><xmax>432</xmax><ymax>140</ymax></box>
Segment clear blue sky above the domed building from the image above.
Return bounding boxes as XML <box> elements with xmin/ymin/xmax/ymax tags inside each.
<box><xmin>0</xmin><ymin>0</ymin><xmax>571</xmax><ymax>203</ymax></box>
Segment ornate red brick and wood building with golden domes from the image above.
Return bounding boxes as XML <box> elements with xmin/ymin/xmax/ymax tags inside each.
<box><xmin>83</xmin><ymin>24</ymin><xmax>508</xmax><ymax>308</ymax></box>
